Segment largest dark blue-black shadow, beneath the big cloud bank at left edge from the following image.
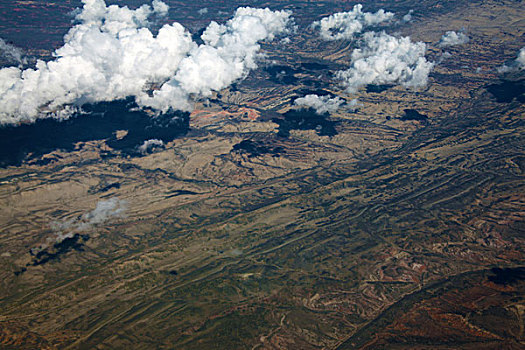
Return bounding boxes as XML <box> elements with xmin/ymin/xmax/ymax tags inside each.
<box><xmin>0</xmin><ymin>99</ymin><xmax>189</xmax><ymax>167</ymax></box>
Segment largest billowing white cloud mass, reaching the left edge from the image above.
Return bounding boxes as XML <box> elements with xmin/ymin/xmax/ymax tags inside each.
<box><xmin>0</xmin><ymin>0</ymin><xmax>186</xmax><ymax>124</ymax></box>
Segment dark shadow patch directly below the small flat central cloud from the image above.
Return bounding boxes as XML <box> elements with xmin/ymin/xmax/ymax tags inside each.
<box><xmin>273</xmin><ymin>108</ymin><xmax>337</xmax><ymax>137</ymax></box>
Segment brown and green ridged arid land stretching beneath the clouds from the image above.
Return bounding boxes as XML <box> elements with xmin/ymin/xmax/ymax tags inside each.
<box><xmin>0</xmin><ymin>0</ymin><xmax>525</xmax><ymax>349</ymax></box>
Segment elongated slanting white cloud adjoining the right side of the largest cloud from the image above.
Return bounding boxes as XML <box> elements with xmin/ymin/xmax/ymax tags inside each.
<box><xmin>139</xmin><ymin>7</ymin><xmax>292</xmax><ymax>111</ymax></box>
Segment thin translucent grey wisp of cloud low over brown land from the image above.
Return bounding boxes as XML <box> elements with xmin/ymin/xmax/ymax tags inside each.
<box><xmin>51</xmin><ymin>197</ymin><xmax>127</xmax><ymax>242</ymax></box>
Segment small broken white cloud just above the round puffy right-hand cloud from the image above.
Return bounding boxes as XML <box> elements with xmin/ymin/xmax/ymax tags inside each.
<box><xmin>312</xmin><ymin>4</ymin><xmax>394</xmax><ymax>40</ymax></box>
